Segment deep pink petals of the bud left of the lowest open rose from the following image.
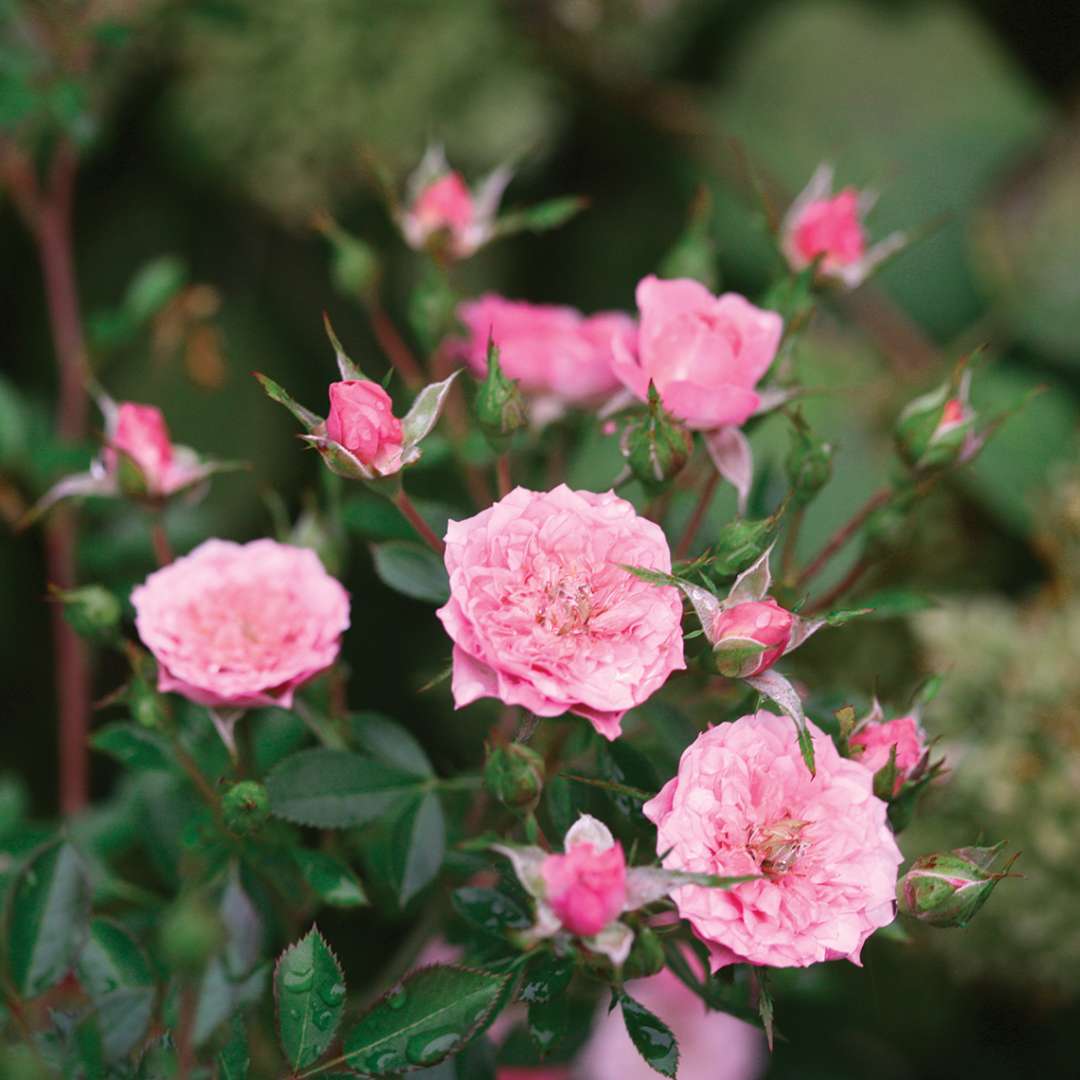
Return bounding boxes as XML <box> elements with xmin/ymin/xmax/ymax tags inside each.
<box><xmin>541</xmin><ymin>842</ymin><xmax>626</xmax><ymax>937</ymax></box>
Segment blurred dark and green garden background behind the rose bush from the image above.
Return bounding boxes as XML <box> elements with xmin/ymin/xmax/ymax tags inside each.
<box><xmin>0</xmin><ymin>0</ymin><xmax>1080</xmax><ymax>1078</ymax></box>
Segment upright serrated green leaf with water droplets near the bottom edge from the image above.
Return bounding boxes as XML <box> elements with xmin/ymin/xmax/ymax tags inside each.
<box><xmin>273</xmin><ymin>927</ymin><xmax>345</xmax><ymax>1069</ymax></box>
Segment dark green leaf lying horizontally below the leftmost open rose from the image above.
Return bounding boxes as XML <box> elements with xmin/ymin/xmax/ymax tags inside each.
<box><xmin>266</xmin><ymin>748</ymin><xmax>423</xmax><ymax>828</ymax></box>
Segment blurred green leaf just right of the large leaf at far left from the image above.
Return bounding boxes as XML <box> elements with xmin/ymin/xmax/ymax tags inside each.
<box><xmin>76</xmin><ymin>918</ymin><xmax>154</xmax><ymax>1062</ymax></box>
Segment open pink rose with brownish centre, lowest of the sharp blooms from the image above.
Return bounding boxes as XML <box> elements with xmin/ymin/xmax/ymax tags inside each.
<box><xmin>644</xmin><ymin>712</ymin><xmax>902</xmax><ymax>971</ymax></box>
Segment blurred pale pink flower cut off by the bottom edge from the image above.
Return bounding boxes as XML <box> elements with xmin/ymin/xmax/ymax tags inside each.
<box><xmin>574</xmin><ymin>967</ymin><xmax>768</xmax><ymax>1080</ymax></box>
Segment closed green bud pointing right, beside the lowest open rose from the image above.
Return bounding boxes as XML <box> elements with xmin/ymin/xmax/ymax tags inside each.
<box><xmin>896</xmin><ymin>843</ymin><xmax>1011</xmax><ymax>927</ymax></box>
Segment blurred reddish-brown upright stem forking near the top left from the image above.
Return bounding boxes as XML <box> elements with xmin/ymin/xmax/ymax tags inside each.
<box><xmin>0</xmin><ymin>138</ymin><xmax>91</xmax><ymax>814</ymax></box>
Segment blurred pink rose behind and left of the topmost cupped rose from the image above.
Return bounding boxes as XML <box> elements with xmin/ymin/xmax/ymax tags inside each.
<box><xmin>458</xmin><ymin>293</ymin><xmax>637</xmax><ymax>405</ymax></box>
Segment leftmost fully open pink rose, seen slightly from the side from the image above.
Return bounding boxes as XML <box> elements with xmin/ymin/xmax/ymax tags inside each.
<box><xmin>132</xmin><ymin>540</ymin><xmax>349</xmax><ymax>708</ymax></box>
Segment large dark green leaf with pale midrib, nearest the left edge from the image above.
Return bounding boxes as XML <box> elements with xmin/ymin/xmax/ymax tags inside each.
<box><xmin>8</xmin><ymin>840</ymin><xmax>91</xmax><ymax>997</ymax></box>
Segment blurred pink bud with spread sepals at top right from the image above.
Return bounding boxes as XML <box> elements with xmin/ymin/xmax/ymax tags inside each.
<box><xmin>780</xmin><ymin>165</ymin><xmax>907</xmax><ymax>288</ymax></box>
